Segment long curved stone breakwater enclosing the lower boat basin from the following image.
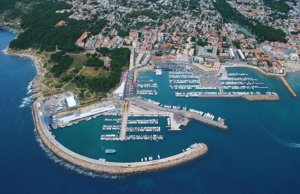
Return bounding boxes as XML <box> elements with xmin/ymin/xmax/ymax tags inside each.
<box><xmin>32</xmin><ymin>101</ymin><xmax>208</xmax><ymax>175</ymax></box>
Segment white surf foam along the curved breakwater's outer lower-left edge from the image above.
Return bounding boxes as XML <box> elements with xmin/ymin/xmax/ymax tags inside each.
<box><xmin>34</xmin><ymin>129</ymin><xmax>122</xmax><ymax>179</ymax></box>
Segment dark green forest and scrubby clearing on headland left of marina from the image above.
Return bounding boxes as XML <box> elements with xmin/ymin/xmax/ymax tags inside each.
<box><xmin>0</xmin><ymin>0</ymin><xmax>128</xmax><ymax>101</ymax></box>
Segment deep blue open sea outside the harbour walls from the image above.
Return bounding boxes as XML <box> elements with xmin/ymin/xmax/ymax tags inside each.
<box><xmin>0</xmin><ymin>31</ymin><xmax>300</xmax><ymax>194</ymax></box>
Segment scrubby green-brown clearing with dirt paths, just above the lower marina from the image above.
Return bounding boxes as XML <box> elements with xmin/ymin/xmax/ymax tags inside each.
<box><xmin>39</xmin><ymin>48</ymin><xmax>130</xmax><ymax>102</ymax></box>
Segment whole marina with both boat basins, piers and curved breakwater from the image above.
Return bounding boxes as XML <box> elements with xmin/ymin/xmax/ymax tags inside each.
<box><xmin>9</xmin><ymin>0</ymin><xmax>296</xmax><ymax>174</ymax></box>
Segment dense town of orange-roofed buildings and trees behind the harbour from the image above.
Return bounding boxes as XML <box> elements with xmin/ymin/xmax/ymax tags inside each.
<box><xmin>52</xmin><ymin>0</ymin><xmax>300</xmax><ymax>74</ymax></box>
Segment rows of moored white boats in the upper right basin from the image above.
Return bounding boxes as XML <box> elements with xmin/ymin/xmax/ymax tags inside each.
<box><xmin>163</xmin><ymin>68</ymin><xmax>277</xmax><ymax>100</ymax></box>
